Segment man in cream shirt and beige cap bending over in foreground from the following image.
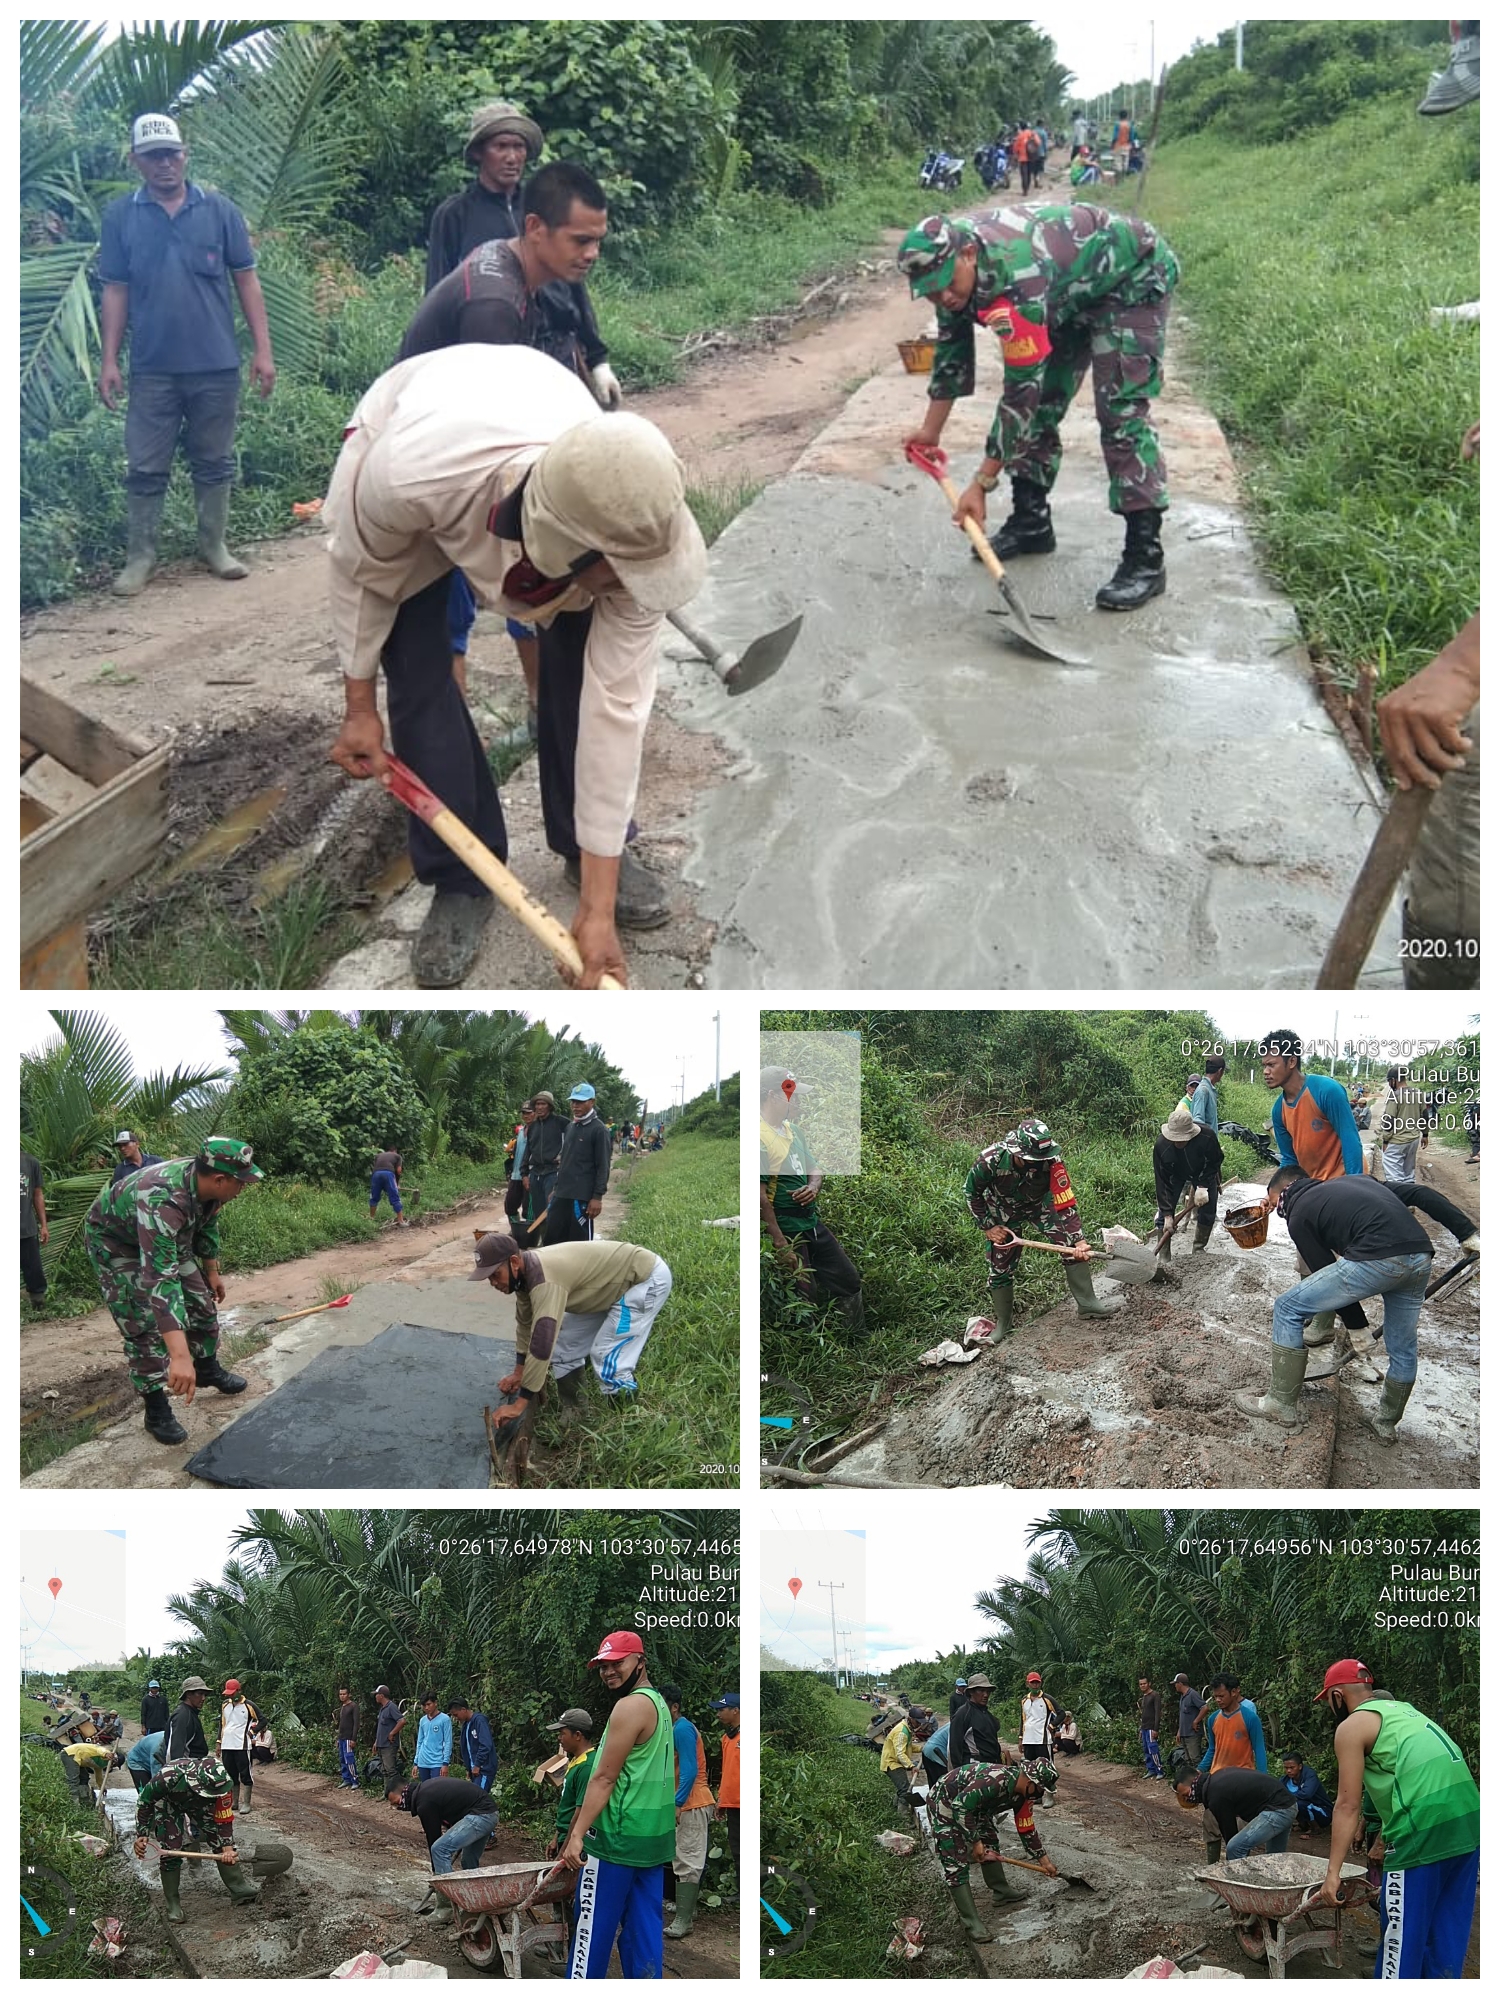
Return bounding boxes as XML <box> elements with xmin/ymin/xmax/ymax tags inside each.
<box><xmin>324</xmin><ymin>355</ymin><xmax>708</xmax><ymax>986</ymax></box>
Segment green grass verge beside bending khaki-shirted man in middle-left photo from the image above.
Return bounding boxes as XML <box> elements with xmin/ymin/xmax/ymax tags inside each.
<box><xmin>540</xmin><ymin>1133</ymin><xmax>740</xmax><ymax>1491</ymax></box>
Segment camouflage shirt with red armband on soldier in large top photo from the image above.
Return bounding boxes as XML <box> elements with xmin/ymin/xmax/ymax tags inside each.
<box><xmin>928</xmin><ymin>202</ymin><xmax>1178</xmax><ymax>464</ymax></box>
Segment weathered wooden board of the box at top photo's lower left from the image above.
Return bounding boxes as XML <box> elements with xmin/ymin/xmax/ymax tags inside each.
<box><xmin>20</xmin><ymin>748</ymin><xmax>168</xmax><ymax>956</ymax></box>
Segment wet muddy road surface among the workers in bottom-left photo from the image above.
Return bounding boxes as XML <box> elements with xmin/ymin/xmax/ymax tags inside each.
<box><xmin>98</xmin><ymin>1727</ymin><xmax>738</xmax><ymax>1979</ymax></box>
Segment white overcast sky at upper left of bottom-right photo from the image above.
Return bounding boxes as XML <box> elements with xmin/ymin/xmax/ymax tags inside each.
<box><xmin>760</xmin><ymin>1493</ymin><xmax>1044</xmax><ymax>1673</ymax></box>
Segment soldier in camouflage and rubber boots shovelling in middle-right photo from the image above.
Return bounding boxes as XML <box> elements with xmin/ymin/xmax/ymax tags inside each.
<box><xmin>964</xmin><ymin>1117</ymin><xmax>1120</xmax><ymax>1339</ymax></box>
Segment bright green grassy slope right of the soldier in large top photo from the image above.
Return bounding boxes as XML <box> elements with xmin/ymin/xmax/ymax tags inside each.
<box><xmin>1146</xmin><ymin>96</ymin><xmax>1480</xmax><ymax>694</ymax></box>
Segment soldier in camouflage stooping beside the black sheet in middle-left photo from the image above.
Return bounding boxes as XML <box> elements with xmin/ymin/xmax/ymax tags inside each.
<box><xmin>84</xmin><ymin>1137</ymin><xmax>262</xmax><ymax>1443</ymax></box>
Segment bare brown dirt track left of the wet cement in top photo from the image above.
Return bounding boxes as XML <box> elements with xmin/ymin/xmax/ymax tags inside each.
<box><xmin>22</xmin><ymin>258</ymin><xmax>926</xmax><ymax>988</ymax></box>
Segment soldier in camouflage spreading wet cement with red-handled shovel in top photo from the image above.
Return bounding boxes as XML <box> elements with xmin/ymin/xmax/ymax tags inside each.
<box><xmin>896</xmin><ymin>202</ymin><xmax>1178</xmax><ymax>612</ymax></box>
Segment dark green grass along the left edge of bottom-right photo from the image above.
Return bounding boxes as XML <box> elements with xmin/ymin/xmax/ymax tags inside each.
<box><xmin>760</xmin><ymin>1673</ymin><xmax>970</xmax><ymax>1979</ymax></box>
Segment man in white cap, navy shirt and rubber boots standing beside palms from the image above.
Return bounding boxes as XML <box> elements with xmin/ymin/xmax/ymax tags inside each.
<box><xmin>98</xmin><ymin>112</ymin><xmax>276</xmax><ymax>598</ymax></box>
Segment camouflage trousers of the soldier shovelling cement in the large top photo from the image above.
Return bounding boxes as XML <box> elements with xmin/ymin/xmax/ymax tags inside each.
<box><xmin>1006</xmin><ymin>275</ymin><xmax>1172</xmax><ymax>514</ymax></box>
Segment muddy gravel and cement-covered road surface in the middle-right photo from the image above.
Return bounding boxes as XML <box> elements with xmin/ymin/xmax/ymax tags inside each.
<box><xmin>824</xmin><ymin>1145</ymin><xmax>1480</xmax><ymax>1491</ymax></box>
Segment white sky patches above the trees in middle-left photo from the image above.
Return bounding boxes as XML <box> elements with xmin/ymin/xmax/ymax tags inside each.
<box><xmin>18</xmin><ymin>994</ymin><xmax>736</xmax><ymax>1109</ymax></box>
